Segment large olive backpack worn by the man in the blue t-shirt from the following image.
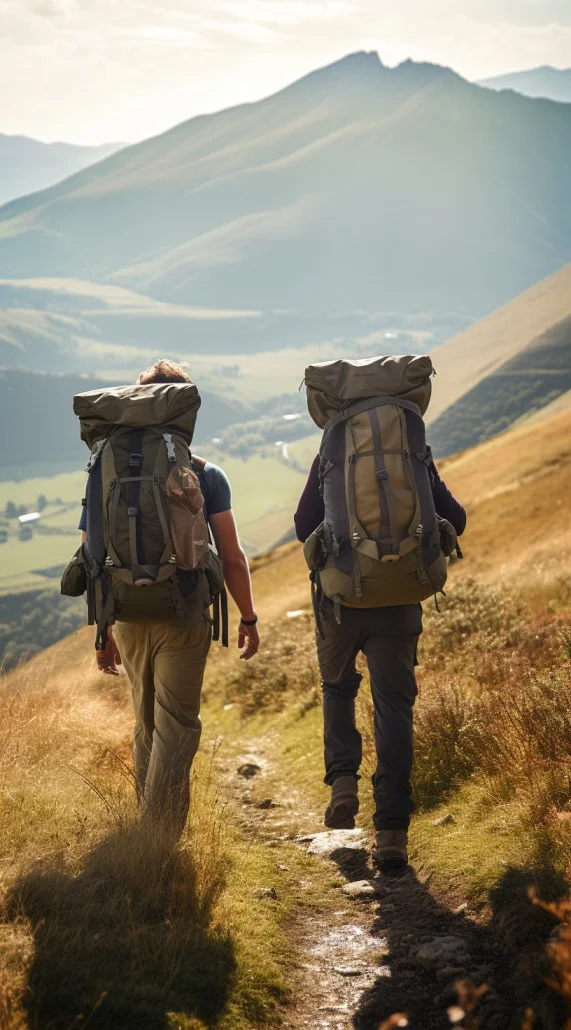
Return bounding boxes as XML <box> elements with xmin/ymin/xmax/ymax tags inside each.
<box><xmin>62</xmin><ymin>382</ymin><xmax>228</xmax><ymax>648</ymax></box>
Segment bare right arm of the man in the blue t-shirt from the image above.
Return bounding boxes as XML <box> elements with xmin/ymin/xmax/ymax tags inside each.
<box><xmin>210</xmin><ymin>511</ymin><xmax>260</xmax><ymax>661</ymax></box>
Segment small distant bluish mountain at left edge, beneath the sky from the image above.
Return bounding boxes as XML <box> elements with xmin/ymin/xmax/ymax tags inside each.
<box><xmin>0</xmin><ymin>133</ymin><xmax>123</xmax><ymax>204</ymax></box>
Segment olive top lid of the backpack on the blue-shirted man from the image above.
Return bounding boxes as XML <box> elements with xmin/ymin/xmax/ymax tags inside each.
<box><xmin>73</xmin><ymin>382</ymin><xmax>200</xmax><ymax>447</ymax></box>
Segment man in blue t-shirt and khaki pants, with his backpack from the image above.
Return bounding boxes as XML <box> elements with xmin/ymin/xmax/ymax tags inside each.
<box><xmin>74</xmin><ymin>361</ymin><xmax>260</xmax><ymax>837</ymax></box>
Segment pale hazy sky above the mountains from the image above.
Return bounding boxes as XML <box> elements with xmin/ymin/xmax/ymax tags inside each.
<box><xmin>0</xmin><ymin>0</ymin><xmax>571</xmax><ymax>143</ymax></box>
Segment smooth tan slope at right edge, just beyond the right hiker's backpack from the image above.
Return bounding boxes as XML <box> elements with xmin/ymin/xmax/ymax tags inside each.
<box><xmin>428</xmin><ymin>265</ymin><xmax>571</xmax><ymax>424</ymax></box>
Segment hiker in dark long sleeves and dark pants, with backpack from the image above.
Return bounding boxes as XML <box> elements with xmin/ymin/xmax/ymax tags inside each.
<box><xmin>295</xmin><ymin>355</ymin><xmax>466</xmax><ymax>872</ymax></box>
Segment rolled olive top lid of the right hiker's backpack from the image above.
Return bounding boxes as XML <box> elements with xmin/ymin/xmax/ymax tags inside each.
<box><xmin>305</xmin><ymin>354</ymin><xmax>434</xmax><ymax>430</ymax></box>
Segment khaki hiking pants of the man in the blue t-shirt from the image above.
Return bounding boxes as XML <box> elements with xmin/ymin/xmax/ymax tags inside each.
<box><xmin>114</xmin><ymin>618</ymin><xmax>211</xmax><ymax>835</ymax></box>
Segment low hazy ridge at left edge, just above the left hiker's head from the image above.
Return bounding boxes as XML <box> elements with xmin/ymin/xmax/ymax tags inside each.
<box><xmin>0</xmin><ymin>279</ymin><xmax>261</xmax><ymax>375</ymax></box>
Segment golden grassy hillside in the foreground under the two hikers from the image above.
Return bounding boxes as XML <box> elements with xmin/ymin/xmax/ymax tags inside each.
<box><xmin>0</xmin><ymin>403</ymin><xmax>571</xmax><ymax>1030</ymax></box>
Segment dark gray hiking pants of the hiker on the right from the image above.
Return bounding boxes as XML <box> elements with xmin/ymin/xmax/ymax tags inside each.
<box><xmin>316</xmin><ymin>600</ymin><xmax>423</xmax><ymax>830</ymax></box>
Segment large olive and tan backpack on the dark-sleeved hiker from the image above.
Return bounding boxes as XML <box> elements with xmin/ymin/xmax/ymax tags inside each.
<box><xmin>305</xmin><ymin>355</ymin><xmax>457</xmax><ymax>620</ymax></box>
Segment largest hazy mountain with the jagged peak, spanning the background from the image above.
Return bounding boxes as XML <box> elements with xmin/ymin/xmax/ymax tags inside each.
<box><xmin>0</xmin><ymin>54</ymin><xmax>571</xmax><ymax>314</ymax></box>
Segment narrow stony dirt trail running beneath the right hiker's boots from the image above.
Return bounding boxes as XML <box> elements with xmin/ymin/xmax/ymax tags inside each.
<box><xmin>219</xmin><ymin>737</ymin><xmax>517</xmax><ymax>1030</ymax></box>
